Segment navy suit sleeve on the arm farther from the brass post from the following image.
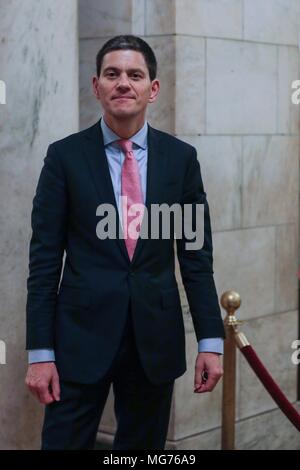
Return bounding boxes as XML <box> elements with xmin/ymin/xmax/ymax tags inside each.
<box><xmin>26</xmin><ymin>144</ymin><xmax>67</xmax><ymax>350</ymax></box>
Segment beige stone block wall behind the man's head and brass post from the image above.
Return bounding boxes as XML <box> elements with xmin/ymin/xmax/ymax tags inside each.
<box><xmin>79</xmin><ymin>0</ymin><xmax>300</xmax><ymax>449</ymax></box>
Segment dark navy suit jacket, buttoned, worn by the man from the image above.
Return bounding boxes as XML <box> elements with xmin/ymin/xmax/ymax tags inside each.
<box><xmin>26</xmin><ymin>122</ymin><xmax>224</xmax><ymax>384</ymax></box>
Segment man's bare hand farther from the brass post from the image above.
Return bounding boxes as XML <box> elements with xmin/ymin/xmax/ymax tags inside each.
<box><xmin>25</xmin><ymin>362</ymin><xmax>60</xmax><ymax>405</ymax></box>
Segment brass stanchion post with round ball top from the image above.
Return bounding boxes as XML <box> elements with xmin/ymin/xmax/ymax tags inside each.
<box><xmin>221</xmin><ymin>291</ymin><xmax>241</xmax><ymax>450</ymax></box>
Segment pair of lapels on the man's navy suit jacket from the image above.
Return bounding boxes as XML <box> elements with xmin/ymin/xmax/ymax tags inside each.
<box><xmin>84</xmin><ymin>121</ymin><xmax>167</xmax><ymax>265</ymax></box>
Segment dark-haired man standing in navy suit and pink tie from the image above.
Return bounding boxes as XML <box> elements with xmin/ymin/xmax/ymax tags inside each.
<box><xmin>26</xmin><ymin>36</ymin><xmax>224</xmax><ymax>450</ymax></box>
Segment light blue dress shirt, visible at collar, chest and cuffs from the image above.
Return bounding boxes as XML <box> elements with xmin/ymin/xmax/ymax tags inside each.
<box><xmin>29</xmin><ymin>117</ymin><xmax>223</xmax><ymax>364</ymax></box>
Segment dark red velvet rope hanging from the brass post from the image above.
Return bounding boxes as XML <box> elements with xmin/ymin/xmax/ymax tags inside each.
<box><xmin>241</xmin><ymin>346</ymin><xmax>300</xmax><ymax>431</ymax></box>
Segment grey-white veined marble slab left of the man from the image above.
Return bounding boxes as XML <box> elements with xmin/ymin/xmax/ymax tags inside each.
<box><xmin>0</xmin><ymin>0</ymin><xmax>79</xmax><ymax>449</ymax></box>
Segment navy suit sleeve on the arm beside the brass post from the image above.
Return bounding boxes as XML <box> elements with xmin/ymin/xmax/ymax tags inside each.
<box><xmin>176</xmin><ymin>147</ymin><xmax>225</xmax><ymax>342</ymax></box>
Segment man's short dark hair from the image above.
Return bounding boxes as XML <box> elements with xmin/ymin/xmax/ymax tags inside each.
<box><xmin>96</xmin><ymin>34</ymin><xmax>157</xmax><ymax>81</ymax></box>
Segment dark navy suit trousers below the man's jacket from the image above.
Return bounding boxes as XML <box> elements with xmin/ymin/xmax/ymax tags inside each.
<box><xmin>42</xmin><ymin>308</ymin><xmax>174</xmax><ymax>450</ymax></box>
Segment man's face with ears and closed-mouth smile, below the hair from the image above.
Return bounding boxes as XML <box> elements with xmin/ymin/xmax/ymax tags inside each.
<box><xmin>93</xmin><ymin>50</ymin><xmax>159</xmax><ymax>119</ymax></box>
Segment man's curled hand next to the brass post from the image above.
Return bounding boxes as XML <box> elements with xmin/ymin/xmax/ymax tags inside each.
<box><xmin>194</xmin><ymin>352</ymin><xmax>223</xmax><ymax>393</ymax></box>
